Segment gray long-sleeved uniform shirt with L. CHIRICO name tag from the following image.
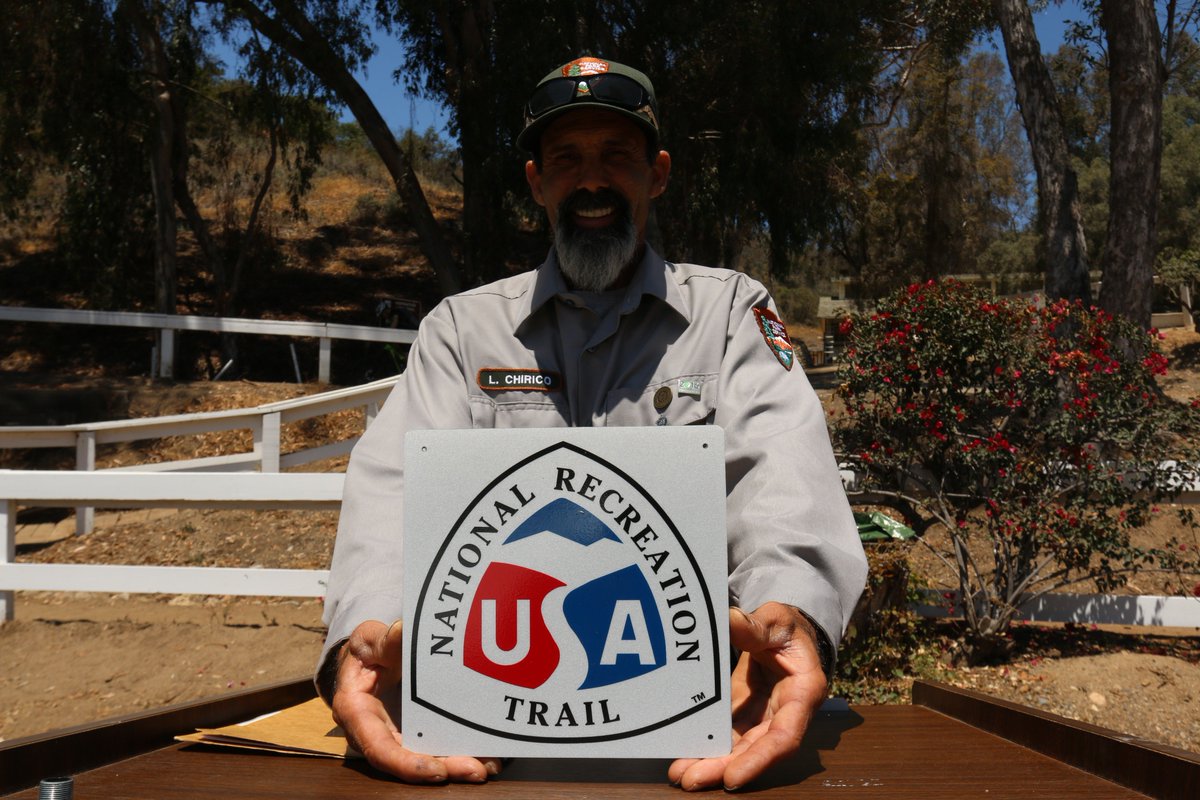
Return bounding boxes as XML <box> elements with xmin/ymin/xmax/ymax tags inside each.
<box><xmin>322</xmin><ymin>247</ymin><xmax>866</xmax><ymax>662</ymax></box>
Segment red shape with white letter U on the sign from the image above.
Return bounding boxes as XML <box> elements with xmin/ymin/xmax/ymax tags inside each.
<box><xmin>462</xmin><ymin>561</ymin><xmax>566</xmax><ymax>688</ymax></box>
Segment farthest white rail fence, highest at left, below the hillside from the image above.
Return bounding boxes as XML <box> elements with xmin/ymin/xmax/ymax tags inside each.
<box><xmin>0</xmin><ymin>306</ymin><xmax>416</xmax><ymax>384</ymax></box>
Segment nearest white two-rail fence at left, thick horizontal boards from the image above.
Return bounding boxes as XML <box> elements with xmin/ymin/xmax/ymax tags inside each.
<box><xmin>0</xmin><ymin>470</ymin><xmax>346</xmax><ymax>622</ymax></box>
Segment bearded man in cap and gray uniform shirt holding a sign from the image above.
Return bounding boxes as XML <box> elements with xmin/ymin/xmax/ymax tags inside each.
<box><xmin>318</xmin><ymin>58</ymin><xmax>866</xmax><ymax>790</ymax></box>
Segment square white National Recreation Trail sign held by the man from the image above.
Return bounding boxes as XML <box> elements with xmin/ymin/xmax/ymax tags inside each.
<box><xmin>403</xmin><ymin>431</ymin><xmax>730</xmax><ymax>754</ymax></box>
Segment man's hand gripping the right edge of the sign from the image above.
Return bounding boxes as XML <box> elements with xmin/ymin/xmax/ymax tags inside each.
<box><xmin>667</xmin><ymin>603</ymin><xmax>828</xmax><ymax>792</ymax></box>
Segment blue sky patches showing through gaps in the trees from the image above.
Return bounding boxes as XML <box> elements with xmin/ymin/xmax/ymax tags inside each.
<box><xmin>220</xmin><ymin>0</ymin><xmax>1082</xmax><ymax>136</ymax></box>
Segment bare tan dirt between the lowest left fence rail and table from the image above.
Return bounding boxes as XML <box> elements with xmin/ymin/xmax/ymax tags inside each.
<box><xmin>0</xmin><ymin>593</ymin><xmax>323</xmax><ymax>740</ymax></box>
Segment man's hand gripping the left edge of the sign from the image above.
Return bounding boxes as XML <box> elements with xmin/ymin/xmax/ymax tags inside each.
<box><xmin>332</xmin><ymin>620</ymin><xmax>500</xmax><ymax>783</ymax></box>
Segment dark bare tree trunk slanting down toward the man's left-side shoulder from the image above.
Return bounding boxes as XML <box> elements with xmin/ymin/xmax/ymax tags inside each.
<box><xmin>223</xmin><ymin>0</ymin><xmax>462</xmax><ymax>295</ymax></box>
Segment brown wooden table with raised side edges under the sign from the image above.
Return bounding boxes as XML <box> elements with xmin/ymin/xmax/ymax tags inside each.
<box><xmin>0</xmin><ymin>681</ymin><xmax>1200</xmax><ymax>800</ymax></box>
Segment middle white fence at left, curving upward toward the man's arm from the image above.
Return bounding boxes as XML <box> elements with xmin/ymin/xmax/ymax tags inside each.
<box><xmin>0</xmin><ymin>377</ymin><xmax>398</xmax><ymax>534</ymax></box>
